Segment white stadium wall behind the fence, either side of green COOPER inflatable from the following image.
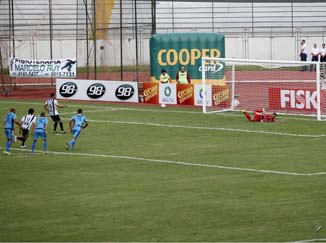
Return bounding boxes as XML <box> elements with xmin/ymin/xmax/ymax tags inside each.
<box><xmin>0</xmin><ymin>37</ymin><xmax>325</xmax><ymax>67</ymax></box>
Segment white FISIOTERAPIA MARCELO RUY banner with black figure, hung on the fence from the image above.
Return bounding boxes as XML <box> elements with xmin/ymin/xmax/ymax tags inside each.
<box><xmin>9</xmin><ymin>58</ymin><xmax>77</xmax><ymax>78</ymax></box>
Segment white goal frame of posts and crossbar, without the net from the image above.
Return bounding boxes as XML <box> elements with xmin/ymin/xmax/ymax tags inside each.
<box><xmin>201</xmin><ymin>57</ymin><xmax>326</xmax><ymax>121</ymax></box>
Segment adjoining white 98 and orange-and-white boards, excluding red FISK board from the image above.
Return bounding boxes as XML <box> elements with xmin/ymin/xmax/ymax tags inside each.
<box><xmin>56</xmin><ymin>79</ymin><xmax>230</xmax><ymax>107</ymax></box>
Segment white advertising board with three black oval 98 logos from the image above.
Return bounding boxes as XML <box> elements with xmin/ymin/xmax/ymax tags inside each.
<box><xmin>56</xmin><ymin>79</ymin><xmax>138</xmax><ymax>102</ymax></box>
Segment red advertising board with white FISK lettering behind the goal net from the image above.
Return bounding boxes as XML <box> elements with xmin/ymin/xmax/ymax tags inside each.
<box><xmin>268</xmin><ymin>88</ymin><xmax>318</xmax><ymax>111</ymax></box>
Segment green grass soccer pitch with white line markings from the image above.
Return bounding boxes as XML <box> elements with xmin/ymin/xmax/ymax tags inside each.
<box><xmin>0</xmin><ymin>99</ymin><xmax>326</xmax><ymax>242</ymax></box>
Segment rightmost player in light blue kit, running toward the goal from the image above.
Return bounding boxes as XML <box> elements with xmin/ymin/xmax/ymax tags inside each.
<box><xmin>66</xmin><ymin>109</ymin><xmax>88</xmax><ymax>150</ymax></box>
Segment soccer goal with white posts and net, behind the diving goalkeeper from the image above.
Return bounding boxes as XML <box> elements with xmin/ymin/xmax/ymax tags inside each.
<box><xmin>202</xmin><ymin>57</ymin><xmax>326</xmax><ymax>120</ymax></box>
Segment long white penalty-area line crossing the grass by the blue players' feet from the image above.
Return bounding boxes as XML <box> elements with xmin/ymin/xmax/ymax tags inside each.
<box><xmin>0</xmin><ymin>147</ymin><xmax>326</xmax><ymax>176</ymax></box>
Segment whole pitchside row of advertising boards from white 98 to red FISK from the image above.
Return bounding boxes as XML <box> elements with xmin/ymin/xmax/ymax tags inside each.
<box><xmin>56</xmin><ymin>79</ymin><xmax>318</xmax><ymax>111</ymax></box>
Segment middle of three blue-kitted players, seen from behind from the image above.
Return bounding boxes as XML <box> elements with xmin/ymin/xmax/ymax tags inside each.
<box><xmin>31</xmin><ymin>112</ymin><xmax>48</xmax><ymax>154</ymax></box>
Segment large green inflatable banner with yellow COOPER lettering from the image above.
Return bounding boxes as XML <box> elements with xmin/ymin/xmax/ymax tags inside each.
<box><xmin>150</xmin><ymin>33</ymin><xmax>225</xmax><ymax>84</ymax></box>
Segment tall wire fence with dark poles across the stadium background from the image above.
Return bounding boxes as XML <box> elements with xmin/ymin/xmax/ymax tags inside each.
<box><xmin>0</xmin><ymin>0</ymin><xmax>326</xmax><ymax>90</ymax></box>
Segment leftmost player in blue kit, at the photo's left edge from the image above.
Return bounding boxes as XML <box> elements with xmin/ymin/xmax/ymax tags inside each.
<box><xmin>3</xmin><ymin>108</ymin><xmax>20</xmax><ymax>155</ymax></box>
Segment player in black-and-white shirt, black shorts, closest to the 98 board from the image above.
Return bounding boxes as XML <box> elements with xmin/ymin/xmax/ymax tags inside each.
<box><xmin>43</xmin><ymin>93</ymin><xmax>67</xmax><ymax>133</ymax></box>
